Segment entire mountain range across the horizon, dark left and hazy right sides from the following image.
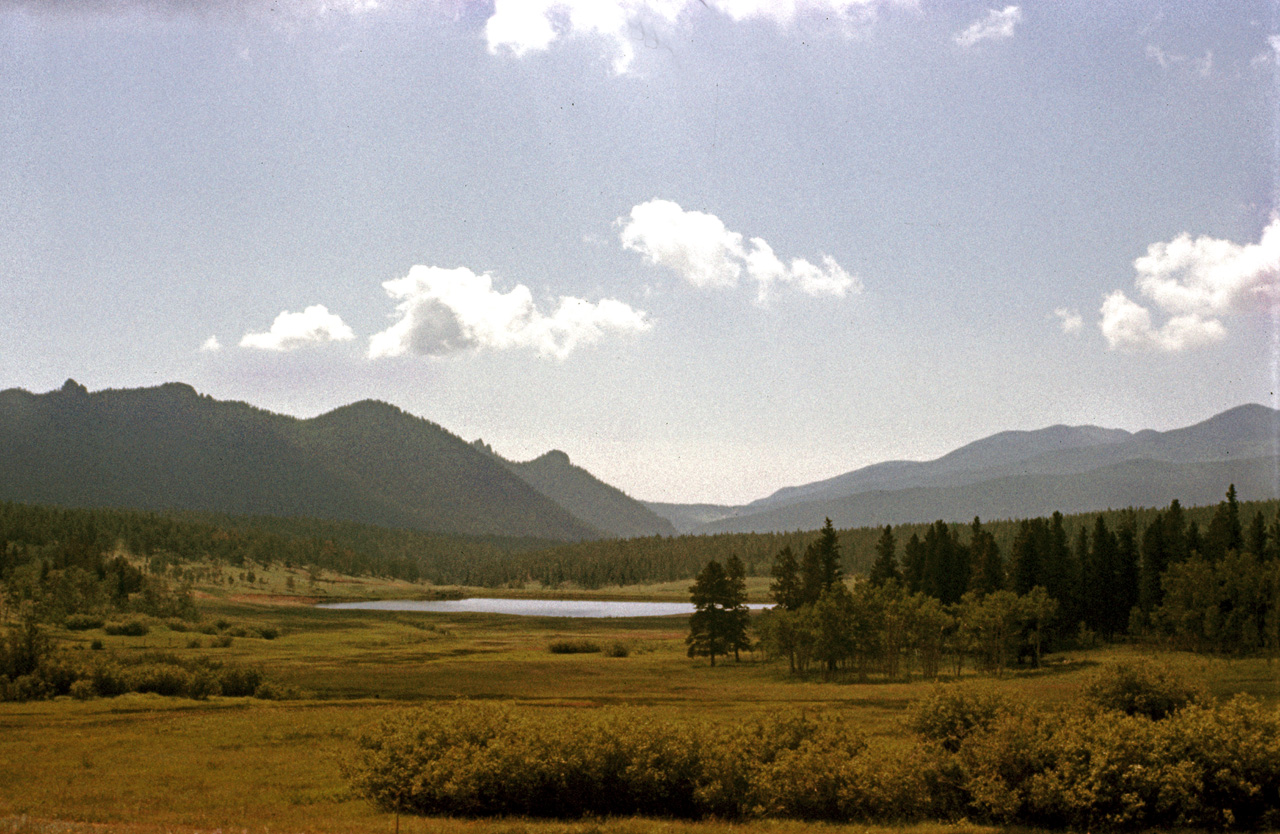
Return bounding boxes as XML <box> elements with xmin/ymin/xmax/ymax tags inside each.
<box><xmin>0</xmin><ymin>380</ymin><xmax>1280</xmax><ymax>541</ymax></box>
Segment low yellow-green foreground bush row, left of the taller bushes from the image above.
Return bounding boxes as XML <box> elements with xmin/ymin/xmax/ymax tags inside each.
<box><xmin>346</xmin><ymin>702</ymin><xmax>947</xmax><ymax>819</ymax></box>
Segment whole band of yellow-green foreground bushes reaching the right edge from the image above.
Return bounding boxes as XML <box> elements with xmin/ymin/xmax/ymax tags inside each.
<box><xmin>344</xmin><ymin>666</ymin><xmax>1280</xmax><ymax>830</ymax></box>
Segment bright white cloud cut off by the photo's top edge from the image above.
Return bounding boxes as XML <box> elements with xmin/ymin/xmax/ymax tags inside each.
<box><xmin>485</xmin><ymin>0</ymin><xmax>915</xmax><ymax>73</ymax></box>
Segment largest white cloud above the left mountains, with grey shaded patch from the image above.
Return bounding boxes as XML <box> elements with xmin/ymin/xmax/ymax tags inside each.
<box><xmin>369</xmin><ymin>266</ymin><xmax>650</xmax><ymax>359</ymax></box>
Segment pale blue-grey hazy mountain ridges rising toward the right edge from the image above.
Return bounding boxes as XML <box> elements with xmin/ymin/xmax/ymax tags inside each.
<box><xmin>650</xmin><ymin>404</ymin><xmax>1280</xmax><ymax>532</ymax></box>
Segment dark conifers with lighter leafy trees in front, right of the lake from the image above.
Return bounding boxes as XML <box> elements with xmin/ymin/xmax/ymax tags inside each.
<box><xmin>689</xmin><ymin>485</ymin><xmax>1280</xmax><ymax>679</ymax></box>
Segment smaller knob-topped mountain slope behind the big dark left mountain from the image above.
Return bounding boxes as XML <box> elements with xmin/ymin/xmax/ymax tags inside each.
<box><xmin>474</xmin><ymin>440</ymin><xmax>676</xmax><ymax>539</ymax></box>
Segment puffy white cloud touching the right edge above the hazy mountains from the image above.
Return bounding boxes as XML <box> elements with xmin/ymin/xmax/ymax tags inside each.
<box><xmin>1098</xmin><ymin>216</ymin><xmax>1280</xmax><ymax>352</ymax></box>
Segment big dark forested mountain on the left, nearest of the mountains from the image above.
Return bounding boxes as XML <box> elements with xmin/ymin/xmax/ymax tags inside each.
<box><xmin>0</xmin><ymin>380</ymin><xmax>603</xmax><ymax>540</ymax></box>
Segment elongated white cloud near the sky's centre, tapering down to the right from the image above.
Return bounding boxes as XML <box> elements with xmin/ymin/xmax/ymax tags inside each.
<box><xmin>618</xmin><ymin>200</ymin><xmax>863</xmax><ymax>303</ymax></box>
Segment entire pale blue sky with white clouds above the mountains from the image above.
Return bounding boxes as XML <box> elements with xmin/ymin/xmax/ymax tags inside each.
<box><xmin>0</xmin><ymin>0</ymin><xmax>1280</xmax><ymax>503</ymax></box>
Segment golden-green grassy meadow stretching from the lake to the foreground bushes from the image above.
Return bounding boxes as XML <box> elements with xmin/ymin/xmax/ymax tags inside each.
<box><xmin>0</xmin><ymin>588</ymin><xmax>1280</xmax><ymax>834</ymax></box>
